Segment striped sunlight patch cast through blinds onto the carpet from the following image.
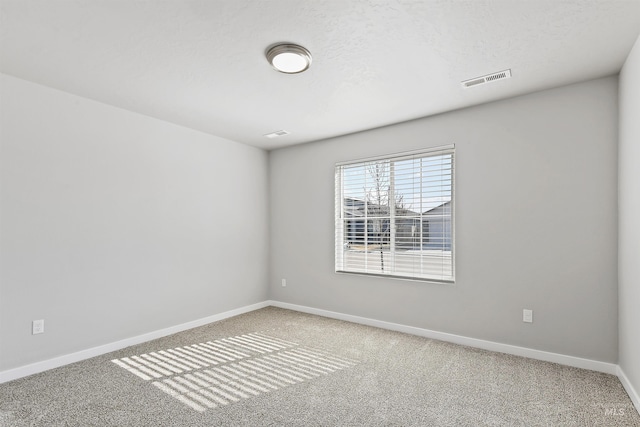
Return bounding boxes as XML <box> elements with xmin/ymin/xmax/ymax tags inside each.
<box><xmin>112</xmin><ymin>332</ymin><xmax>358</xmax><ymax>412</ymax></box>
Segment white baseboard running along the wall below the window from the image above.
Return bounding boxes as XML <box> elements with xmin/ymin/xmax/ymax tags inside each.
<box><xmin>270</xmin><ymin>301</ymin><xmax>618</xmax><ymax>375</ymax></box>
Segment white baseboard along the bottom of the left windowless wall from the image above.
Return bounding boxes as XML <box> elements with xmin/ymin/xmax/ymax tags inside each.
<box><xmin>0</xmin><ymin>301</ymin><xmax>270</xmax><ymax>384</ymax></box>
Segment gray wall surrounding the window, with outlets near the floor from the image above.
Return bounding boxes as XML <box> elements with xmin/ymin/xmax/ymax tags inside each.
<box><xmin>269</xmin><ymin>77</ymin><xmax>620</xmax><ymax>363</ymax></box>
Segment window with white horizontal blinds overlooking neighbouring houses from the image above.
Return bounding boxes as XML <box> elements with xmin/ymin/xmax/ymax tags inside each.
<box><xmin>335</xmin><ymin>145</ymin><xmax>454</xmax><ymax>282</ymax></box>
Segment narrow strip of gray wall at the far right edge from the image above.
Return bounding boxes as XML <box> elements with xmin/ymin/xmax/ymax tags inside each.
<box><xmin>618</xmin><ymin>38</ymin><xmax>640</xmax><ymax>400</ymax></box>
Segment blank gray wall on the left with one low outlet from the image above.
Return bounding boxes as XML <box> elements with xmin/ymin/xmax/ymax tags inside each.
<box><xmin>0</xmin><ymin>76</ymin><xmax>269</xmax><ymax>371</ymax></box>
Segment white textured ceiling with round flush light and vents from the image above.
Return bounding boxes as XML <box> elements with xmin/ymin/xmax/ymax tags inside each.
<box><xmin>0</xmin><ymin>0</ymin><xmax>640</xmax><ymax>149</ymax></box>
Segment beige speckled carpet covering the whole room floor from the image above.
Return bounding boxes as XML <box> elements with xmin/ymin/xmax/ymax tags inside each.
<box><xmin>0</xmin><ymin>307</ymin><xmax>640</xmax><ymax>427</ymax></box>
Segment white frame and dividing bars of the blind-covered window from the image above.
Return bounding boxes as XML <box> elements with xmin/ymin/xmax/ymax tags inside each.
<box><xmin>334</xmin><ymin>144</ymin><xmax>456</xmax><ymax>284</ymax></box>
